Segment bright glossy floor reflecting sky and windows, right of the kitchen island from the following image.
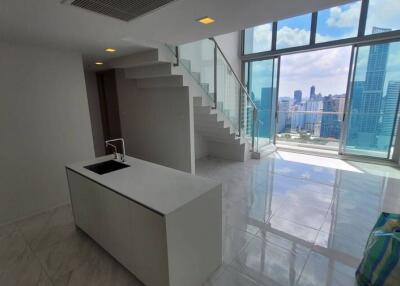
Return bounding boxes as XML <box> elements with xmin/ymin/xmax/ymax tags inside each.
<box><xmin>196</xmin><ymin>152</ymin><xmax>400</xmax><ymax>285</ymax></box>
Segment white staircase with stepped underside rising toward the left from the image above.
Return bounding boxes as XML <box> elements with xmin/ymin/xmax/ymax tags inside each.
<box><xmin>108</xmin><ymin>39</ymin><xmax>251</xmax><ymax>161</ymax></box>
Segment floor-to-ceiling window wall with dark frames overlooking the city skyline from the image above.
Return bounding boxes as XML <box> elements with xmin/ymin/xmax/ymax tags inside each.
<box><xmin>242</xmin><ymin>0</ymin><xmax>400</xmax><ymax>159</ymax></box>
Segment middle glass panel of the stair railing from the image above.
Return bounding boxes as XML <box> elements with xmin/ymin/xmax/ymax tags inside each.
<box><xmin>217</xmin><ymin>50</ymin><xmax>241</xmax><ymax>131</ymax></box>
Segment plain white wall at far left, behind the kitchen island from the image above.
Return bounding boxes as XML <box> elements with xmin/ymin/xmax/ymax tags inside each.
<box><xmin>0</xmin><ymin>43</ymin><xmax>94</xmax><ymax>226</ymax></box>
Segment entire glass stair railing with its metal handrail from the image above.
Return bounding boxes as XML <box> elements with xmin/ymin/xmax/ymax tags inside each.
<box><xmin>167</xmin><ymin>38</ymin><xmax>259</xmax><ymax>152</ymax></box>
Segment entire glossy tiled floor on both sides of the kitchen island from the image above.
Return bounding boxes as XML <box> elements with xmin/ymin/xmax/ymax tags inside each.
<box><xmin>0</xmin><ymin>152</ymin><xmax>400</xmax><ymax>286</ymax></box>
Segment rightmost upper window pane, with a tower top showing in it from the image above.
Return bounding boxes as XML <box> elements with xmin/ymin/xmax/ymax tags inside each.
<box><xmin>365</xmin><ymin>0</ymin><xmax>400</xmax><ymax>35</ymax></box>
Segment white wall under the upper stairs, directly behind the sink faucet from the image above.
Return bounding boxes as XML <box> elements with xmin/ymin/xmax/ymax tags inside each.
<box><xmin>116</xmin><ymin>70</ymin><xmax>195</xmax><ymax>173</ymax></box>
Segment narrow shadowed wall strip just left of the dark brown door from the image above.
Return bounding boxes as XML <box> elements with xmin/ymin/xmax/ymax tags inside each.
<box><xmin>85</xmin><ymin>71</ymin><xmax>106</xmax><ymax>157</ymax></box>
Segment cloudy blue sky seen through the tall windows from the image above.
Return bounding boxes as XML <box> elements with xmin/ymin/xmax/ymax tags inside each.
<box><xmin>247</xmin><ymin>0</ymin><xmax>400</xmax><ymax>98</ymax></box>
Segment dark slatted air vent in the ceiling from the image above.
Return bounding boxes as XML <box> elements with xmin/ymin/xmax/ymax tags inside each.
<box><xmin>61</xmin><ymin>0</ymin><xmax>175</xmax><ymax>21</ymax></box>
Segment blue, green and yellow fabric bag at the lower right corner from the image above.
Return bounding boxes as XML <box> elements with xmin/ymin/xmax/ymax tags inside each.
<box><xmin>356</xmin><ymin>212</ymin><xmax>400</xmax><ymax>286</ymax></box>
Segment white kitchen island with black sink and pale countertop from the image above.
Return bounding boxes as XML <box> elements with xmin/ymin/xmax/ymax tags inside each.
<box><xmin>66</xmin><ymin>156</ymin><xmax>222</xmax><ymax>286</ymax></box>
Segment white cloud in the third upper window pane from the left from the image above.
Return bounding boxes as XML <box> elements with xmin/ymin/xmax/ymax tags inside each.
<box><xmin>326</xmin><ymin>1</ymin><xmax>361</xmax><ymax>28</ymax></box>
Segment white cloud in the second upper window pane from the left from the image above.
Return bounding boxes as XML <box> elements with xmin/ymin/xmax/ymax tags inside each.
<box><xmin>276</xmin><ymin>26</ymin><xmax>310</xmax><ymax>48</ymax></box>
